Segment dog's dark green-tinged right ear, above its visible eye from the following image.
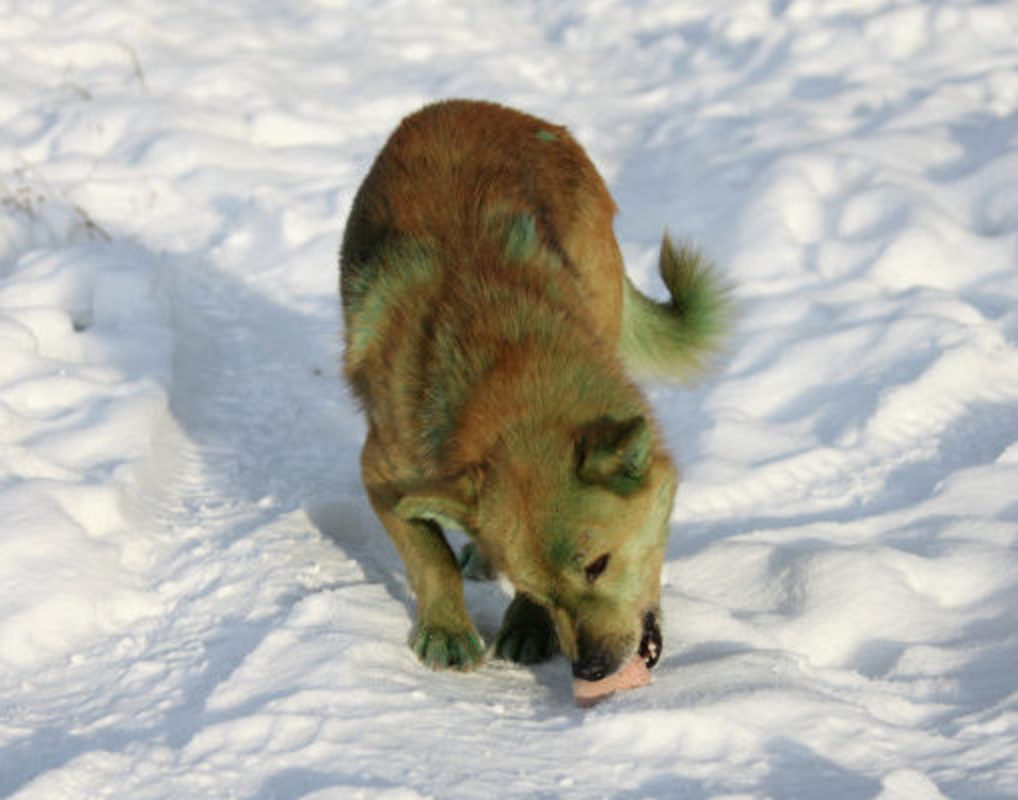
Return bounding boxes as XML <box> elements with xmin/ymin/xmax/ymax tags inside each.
<box><xmin>576</xmin><ymin>415</ymin><xmax>653</xmax><ymax>495</ymax></box>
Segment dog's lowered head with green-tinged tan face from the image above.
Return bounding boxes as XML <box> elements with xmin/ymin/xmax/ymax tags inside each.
<box><xmin>397</xmin><ymin>415</ymin><xmax>678</xmax><ymax>681</ymax></box>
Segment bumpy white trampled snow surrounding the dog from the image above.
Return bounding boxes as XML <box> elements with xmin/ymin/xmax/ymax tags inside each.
<box><xmin>0</xmin><ymin>0</ymin><xmax>1018</xmax><ymax>800</ymax></box>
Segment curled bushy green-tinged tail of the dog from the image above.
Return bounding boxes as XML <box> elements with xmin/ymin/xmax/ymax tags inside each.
<box><xmin>619</xmin><ymin>233</ymin><xmax>733</xmax><ymax>380</ymax></box>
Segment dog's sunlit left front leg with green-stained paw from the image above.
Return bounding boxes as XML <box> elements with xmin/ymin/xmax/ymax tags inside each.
<box><xmin>369</xmin><ymin>490</ymin><xmax>485</xmax><ymax>670</ymax></box>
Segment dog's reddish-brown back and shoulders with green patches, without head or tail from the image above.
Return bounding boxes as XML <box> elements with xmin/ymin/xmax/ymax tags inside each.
<box><xmin>341</xmin><ymin>101</ymin><xmax>624</xmax><ymax>471</ymax></box>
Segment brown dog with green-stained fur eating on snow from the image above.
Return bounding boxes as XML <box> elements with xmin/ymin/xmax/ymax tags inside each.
<box><xmin>340</xmin><ymin>101</ymin><xmax>728</xmax><ymax>681</ymax></box>
